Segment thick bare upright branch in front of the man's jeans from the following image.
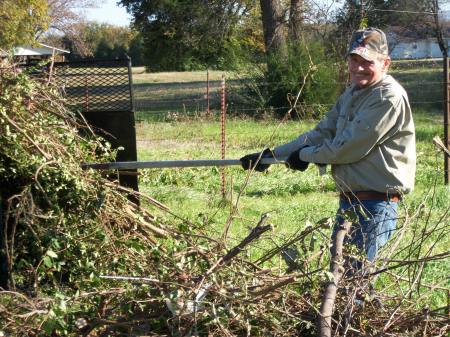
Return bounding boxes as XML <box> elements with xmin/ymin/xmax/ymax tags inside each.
<box><xmin>318</xmin><ymin>221</ymin><xmax>351</xmax><ymax>337</ymax></box>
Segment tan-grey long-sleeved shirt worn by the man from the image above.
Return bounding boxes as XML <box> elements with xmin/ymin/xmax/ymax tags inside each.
<box><xmin>274</xmin><ymin>75</ymin><xmax>416</xmax><ymax>193</ymax></box>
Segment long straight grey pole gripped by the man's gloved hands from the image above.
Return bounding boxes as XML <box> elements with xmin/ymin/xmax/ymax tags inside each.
<box><xmin>81</xmin><ymin>158</ymin><xmax>285</xmax><ymax>170</ymax></box>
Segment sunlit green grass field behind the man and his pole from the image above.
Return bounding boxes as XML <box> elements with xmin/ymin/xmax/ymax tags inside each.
<box><xmin>137</xmin><ymin>71</ymin><xmax>450</xmax><ymax>306</ymax></box>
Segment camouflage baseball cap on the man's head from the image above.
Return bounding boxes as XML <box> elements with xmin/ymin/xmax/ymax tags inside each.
<box><xmin>347</xmin><ymin>27</ymin><xmax>389</xmax><ymax>61</ymax></box>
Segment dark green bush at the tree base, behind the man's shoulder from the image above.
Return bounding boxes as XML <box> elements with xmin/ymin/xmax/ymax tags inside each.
<box><xmin>229</xmin><ymin>39</ymin><xmax>346</xmax><ymax>119</ymax></box>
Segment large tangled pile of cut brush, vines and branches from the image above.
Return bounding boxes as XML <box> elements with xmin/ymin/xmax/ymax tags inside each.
<box><xmin>0</xmin><ymin>67</ymin><xmax>450</xmax><ymax>336</ymax></box>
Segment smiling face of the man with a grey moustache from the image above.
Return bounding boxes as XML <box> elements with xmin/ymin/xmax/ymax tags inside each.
<box><xmin>348</xmin><ymin>54</ymin><xmax>390</xmax><ymax>88</ymax></box>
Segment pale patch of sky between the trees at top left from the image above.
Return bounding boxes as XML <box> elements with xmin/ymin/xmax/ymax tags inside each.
<box><xmin>84</xmin><ymin>0</ymin><xmax>131</xmax><ymax>26</ymax></box>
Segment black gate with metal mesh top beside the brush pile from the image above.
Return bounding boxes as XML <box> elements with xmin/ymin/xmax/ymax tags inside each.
<box><xmin>53</xmin><ymin>59</ymin><xmax>138</xmax><ymax>191</ymax></box>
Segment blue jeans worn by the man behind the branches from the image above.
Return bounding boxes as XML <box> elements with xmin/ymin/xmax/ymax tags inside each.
<box><xmin>332</xmin><ymin>199</ymin><xmax>398</xmax><ymax>261</ymax></box>
